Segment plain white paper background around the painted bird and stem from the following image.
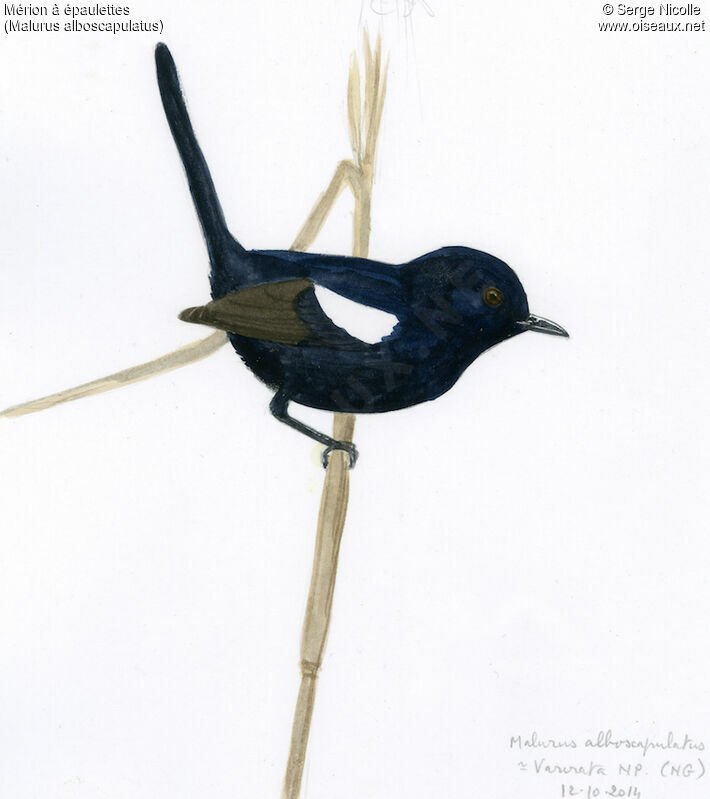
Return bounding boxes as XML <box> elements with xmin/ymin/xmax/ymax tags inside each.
<box><xmin>0</xmin><ymin>0</ymin><xmax>710</xmax><ymax>799</ymax></box>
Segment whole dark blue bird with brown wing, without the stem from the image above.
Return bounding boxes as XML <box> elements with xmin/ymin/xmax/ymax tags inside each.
<box><xmin>155</xmin><ymin>44</ymin><xmax>567</xmax><ymax>465</ymax></box>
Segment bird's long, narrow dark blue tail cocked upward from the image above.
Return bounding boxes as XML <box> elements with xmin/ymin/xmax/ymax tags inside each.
<box><xmin>155</xmin><ymin>42</ymin><xmax>244</xmax><ymax>278</ymax></box>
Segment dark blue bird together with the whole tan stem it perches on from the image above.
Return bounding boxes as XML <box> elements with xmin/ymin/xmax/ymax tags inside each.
<box><xmin>0</xmin><ymin>34</ymin><xmax>568</xmax><ymax>799</ymax></box>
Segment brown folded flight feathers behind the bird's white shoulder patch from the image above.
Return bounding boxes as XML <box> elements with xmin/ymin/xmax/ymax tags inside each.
<box><xmin>179</xmin><ymin>279</ymin><xmax>313</xmax><ymax>344</ymax></box>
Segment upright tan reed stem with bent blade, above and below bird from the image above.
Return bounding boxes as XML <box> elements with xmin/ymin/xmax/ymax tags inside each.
<box><xmin>282</xmin><ymin>34</ymin><xmax>385</xmax><ymax>799</ymax></box>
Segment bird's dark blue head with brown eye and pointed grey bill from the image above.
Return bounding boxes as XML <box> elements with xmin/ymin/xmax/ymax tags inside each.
<box><xmin>408</xmin><ymin>247</ymin><xmax>568</xmax><ymax>352</ymax></box>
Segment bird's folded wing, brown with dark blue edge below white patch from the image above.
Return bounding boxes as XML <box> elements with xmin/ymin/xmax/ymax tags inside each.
<box><xmin>180</xmin><ymin>278</ymin><xmax>397</xmax><ymax>350</ymax></box>
